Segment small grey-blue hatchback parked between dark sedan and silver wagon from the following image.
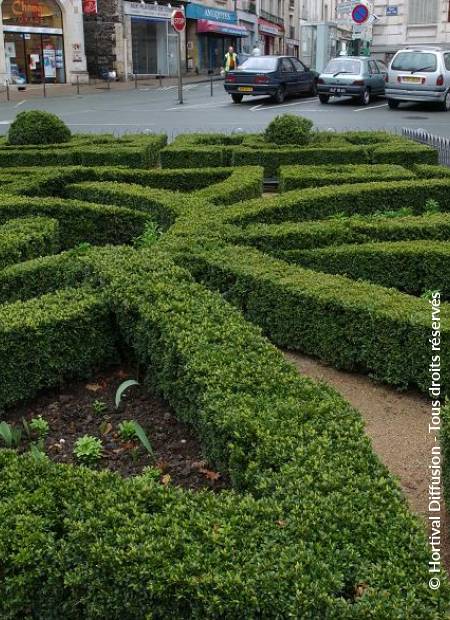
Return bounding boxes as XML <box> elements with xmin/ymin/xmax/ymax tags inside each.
<box><xmin>317</xmin><ymin>56</ymin><xmax>388</xmax><ymax>105</ymax></box>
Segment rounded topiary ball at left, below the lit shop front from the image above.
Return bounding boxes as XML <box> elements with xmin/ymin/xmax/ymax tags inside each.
<box><xmin>8</xmin><ymin>110</ymin><xmax>71</xmax><ymax>144</ymax></box>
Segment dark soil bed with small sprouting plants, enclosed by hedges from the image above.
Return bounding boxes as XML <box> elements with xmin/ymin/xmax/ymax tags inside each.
<box><xmin>3</xmin><ymin>368</ymin><xmax>229</xmax><ymax>491</ymax></box>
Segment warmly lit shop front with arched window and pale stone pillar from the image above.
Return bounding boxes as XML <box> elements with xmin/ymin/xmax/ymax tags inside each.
<box><xmin>0</xmin><ymin>0</ymin><xmax>86</xmax><ymax>85</ymax></box>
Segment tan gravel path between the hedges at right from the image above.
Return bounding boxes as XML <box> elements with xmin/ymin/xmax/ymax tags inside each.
<box><xmin>285</xmin><ymin>353</ymin><xmax>450</xmax><ymax>571</ymax></box>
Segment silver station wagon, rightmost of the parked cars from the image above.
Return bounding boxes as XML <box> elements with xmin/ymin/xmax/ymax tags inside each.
<box><xmin>386</xmin><ymin>47</ymin><xmax>450</xmax><ymax>111</ymax></box>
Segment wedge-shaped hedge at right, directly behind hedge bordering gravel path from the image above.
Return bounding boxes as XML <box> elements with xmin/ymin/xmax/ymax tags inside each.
<box><xmin>279</xmin><ymin>240</ymin><xmax>450</xmax><ymax>299</ymax></box>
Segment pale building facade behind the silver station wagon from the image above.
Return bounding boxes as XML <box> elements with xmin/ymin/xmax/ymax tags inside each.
<box><xmin>372</xmin><ymin>0</ymin><xmax>450</xmax><ymax>61</ymax></box>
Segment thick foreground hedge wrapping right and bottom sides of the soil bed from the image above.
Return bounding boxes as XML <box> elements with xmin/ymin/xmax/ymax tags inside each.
<box><xmin>0</xmin><ymin>249</ymin><xmax>449</xmax><ymax>620</ymax></box>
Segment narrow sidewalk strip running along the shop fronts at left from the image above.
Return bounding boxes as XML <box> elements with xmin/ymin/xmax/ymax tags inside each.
<box><xmin>0</xmin><ymin>74</ymin><xmax>223</xmax><ymax>103</ymax></box>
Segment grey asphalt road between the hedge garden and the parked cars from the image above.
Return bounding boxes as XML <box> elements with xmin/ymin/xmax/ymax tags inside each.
<box><xmin>0</xmin><ymin>82</ymin><xmax>450</xmax><ymax>137</ymax></box>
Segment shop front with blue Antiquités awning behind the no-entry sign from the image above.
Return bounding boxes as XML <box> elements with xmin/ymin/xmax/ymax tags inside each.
<box><xmin>186</xmin><ymin>3</ymin><xmax>248</xmax><ymax>71</ymax></box>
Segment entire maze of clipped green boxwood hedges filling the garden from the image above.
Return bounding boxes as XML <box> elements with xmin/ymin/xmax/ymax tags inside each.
<box><xmin>0</xmin><ymin>132</ymin><xmax>450</xmax><ymax>620</ymax></box>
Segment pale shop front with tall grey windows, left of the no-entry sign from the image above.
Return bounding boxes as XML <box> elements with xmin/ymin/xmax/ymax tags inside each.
<box><xmin>123</xmin><ymin>1</ymin><xmax>178</xmax><ymax>76</ymax></box>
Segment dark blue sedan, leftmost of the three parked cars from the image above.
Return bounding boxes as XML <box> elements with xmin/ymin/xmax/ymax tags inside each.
<box><xmin>224</xmin><ymin>56</ymin><xmax>318</xmax><ymax>103</ymax></box>
